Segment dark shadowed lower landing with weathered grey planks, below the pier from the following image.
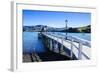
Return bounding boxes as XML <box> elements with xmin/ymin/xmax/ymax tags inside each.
<box><xmin>23</xmin><ymin>51</ymin><xmax>71</xmax><ymax>62</ymax></box>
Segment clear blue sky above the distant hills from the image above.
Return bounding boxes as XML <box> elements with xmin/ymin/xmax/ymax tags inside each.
<box><xmin>23</xmin><ymin>10</ymin><xmax>91</xmax><ymax>28</ymax></box>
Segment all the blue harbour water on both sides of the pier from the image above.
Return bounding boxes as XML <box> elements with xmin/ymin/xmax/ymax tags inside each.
<box><xmin>23</xmin><ymin>32</ymin><xmax>91</xmax><ymax>53</ymax></box>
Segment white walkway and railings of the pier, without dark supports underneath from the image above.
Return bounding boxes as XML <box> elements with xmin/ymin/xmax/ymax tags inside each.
<box><xmin>42</xmin><ymin>32</ymin><xmax>91</xmax><ymax>60</ymax></box>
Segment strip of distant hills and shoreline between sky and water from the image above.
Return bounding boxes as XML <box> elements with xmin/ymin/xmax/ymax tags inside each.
<box><xmin>23</xmin><ymin>25</ymin><xmax>91</xmax><ymax>33</ymax></box>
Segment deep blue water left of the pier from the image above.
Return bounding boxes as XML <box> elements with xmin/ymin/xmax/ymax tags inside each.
<box><xmin>23</xmin><ymin>32</ymin><xmax>46</xmax><ymax>53</ymax></box>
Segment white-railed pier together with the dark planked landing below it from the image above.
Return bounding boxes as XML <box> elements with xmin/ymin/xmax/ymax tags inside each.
<box><xmin>23</xmin><ymin>32</ymin><xmax>91</xmax><ymax>62</ymax></box>
